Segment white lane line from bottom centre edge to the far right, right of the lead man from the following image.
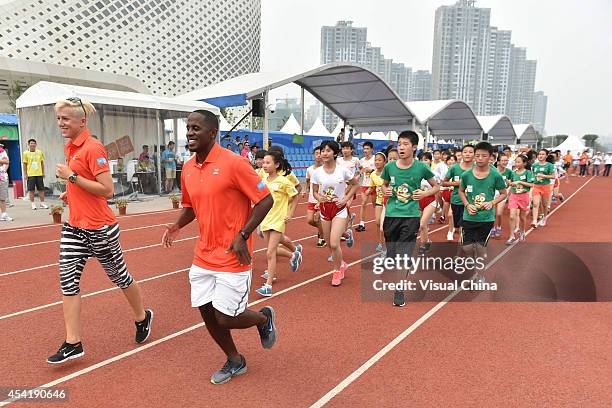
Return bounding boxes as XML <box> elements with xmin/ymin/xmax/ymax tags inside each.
<box><xmin>310</xmin><ymin>179</ymin><xmax>593</xmax><ymax>408</ymax></box>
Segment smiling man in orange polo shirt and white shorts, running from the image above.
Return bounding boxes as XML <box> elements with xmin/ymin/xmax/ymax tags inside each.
<box><xmin>162</xmin><ymin>110</ymin><xmax>276</xmax><ymax>384</ymax></box>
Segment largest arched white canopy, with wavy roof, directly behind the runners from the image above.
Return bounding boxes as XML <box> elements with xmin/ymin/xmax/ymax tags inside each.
<box><xmin>181</xmin><ymin>62</ymin><xmax>414</xmax><ymax>131</ymax></box>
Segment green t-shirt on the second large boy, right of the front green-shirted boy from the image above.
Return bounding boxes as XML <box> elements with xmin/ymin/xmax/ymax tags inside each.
<box><xmin>461</xmin><ymin>169</ymin><xmax>506</xmax><ymax>222</ymax></box>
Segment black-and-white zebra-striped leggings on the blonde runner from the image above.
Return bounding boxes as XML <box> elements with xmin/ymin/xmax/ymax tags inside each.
<box><xmin>59</xmin><ymin>223</ymin><xmax>133</xmax><ymax>296</ymax></box>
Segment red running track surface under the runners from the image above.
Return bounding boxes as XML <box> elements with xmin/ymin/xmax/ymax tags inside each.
<box><xmin>0</xmin><ymin>178</ymin><xmax>612</xmax><ymax>407</ymax></box>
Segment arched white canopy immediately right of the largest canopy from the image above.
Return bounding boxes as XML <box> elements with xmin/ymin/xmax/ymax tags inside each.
<box><xmin>406</xmin><ymin>99</ymin><xmax>482</xmax><ymax>140</ymax></box>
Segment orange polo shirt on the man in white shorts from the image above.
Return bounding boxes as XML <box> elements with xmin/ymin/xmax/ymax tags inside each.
<box><xmin>181</xmin><ymin>144</ymin><xmax>270</xmax><ymax>272</ymax></box>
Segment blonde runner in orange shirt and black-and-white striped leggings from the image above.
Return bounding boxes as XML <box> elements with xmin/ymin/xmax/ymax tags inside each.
<box><xmin>47</xmin><ymin>98</ymin><xmax>153</xmax><ymax>364</ymax></box>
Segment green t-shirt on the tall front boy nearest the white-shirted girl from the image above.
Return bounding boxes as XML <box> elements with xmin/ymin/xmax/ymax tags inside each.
<box><xmin>380</xmin><ymin>160</ymin><xmax>434</xmax><ymax>218</ymax></box>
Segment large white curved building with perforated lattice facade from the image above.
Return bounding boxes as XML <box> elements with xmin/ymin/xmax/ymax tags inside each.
<box><xmin>0</xmin><ymin>0</ymin><xmax>261</xmax><ymax>110</ymax></box>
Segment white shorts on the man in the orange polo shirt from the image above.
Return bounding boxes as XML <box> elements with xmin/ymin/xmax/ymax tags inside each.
<box><xmin>189</xmin><ymin>265</ymin><xmax>251</xmax><ymax>316</ymax></box>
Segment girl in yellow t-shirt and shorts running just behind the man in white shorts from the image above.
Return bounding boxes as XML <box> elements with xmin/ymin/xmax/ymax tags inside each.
<box><xmin>256</xmin><ymin>151</ymin><xmax>302</xmax><ymax>296</ymax></box>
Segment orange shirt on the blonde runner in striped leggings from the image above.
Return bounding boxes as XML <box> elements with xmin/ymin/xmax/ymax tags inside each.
<box><xmin>64</xmin><ymin>129</ymin><xmax>117</xmax><ymax>229</ymax></box>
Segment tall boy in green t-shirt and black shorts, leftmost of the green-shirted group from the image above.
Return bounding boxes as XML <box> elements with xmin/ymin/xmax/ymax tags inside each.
<box><xmin>381</xmin><ymin>130</ymin><xmax>439</xmax><ymax>307</ymax></box>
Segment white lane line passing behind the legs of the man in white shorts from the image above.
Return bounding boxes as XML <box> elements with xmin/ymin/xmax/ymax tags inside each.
<box><xmin>0</xmin><ymin>253</ymin><xmax>378</xmax><ymax>407</ymax></box>
